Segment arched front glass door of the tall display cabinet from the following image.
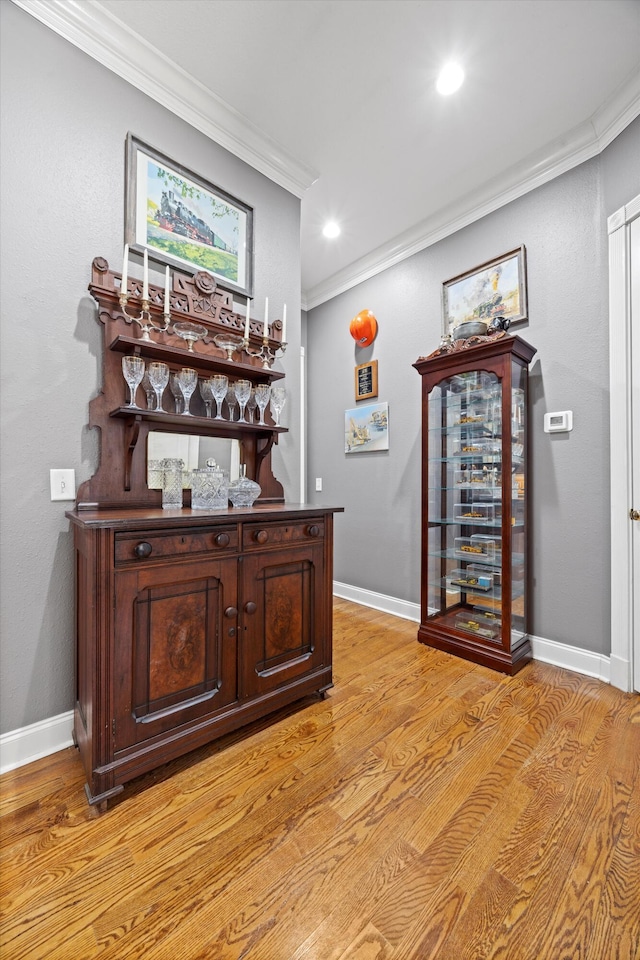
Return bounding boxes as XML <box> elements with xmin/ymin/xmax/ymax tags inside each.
<box><xmin>427</xmin><ymin>371</ymin><xmax>510</xmax><ymax>644</ymax></box>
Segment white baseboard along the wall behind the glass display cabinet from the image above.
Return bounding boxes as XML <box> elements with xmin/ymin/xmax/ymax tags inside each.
<box><xmin>333</xmin><ymin>580</ymin><xmax>611</xmax><ymax>683</ymax></box>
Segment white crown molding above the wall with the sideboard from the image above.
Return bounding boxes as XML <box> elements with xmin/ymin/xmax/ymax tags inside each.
<box><xmin>13</xmin><ymin>0</ymin><xmax>318</xmax><ymax>199</ymax></box>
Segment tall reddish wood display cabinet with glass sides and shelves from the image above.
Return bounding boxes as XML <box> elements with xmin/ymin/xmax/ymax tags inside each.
<box><xmin>414</xmin><ymin>334</ymin><xmax>535</xmax><ymax>674</ymax></box>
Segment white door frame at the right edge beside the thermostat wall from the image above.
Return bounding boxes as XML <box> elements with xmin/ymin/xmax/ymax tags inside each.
<box><xmin>607</xmin><ymin>194</ymin><xmax>640</xmax><ymax>692</ymax></box>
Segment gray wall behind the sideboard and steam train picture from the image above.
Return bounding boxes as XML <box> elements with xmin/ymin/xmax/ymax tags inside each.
<box><xmin>0</xmin><ymin>3</ymin><xmax>300</xmax><ymax>733</ymax></box>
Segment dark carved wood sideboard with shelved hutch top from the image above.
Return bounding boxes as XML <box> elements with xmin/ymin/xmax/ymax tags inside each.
<box><xmin>67</xmin><ymin>258</ymin><xmax>342</xmax><ymax>807</ymax></box>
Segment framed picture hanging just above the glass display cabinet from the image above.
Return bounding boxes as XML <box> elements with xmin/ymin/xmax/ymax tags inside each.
<box><xmin>442</xmin><ymin>246</ymin><xmax>528</xmax><ymax>334</ymax></box>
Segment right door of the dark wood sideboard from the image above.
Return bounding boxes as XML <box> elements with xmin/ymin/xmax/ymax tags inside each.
<box><xmin>241</xmin><ymin>543</ymin><xmax>329</xmax><ymax>697</ymax></box>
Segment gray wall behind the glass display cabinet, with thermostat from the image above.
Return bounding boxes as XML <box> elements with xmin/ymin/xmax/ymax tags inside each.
<box><xmin>306</xmin><ymin>120</ymin><xmax>640</xmax><ymax>655</ymax></box>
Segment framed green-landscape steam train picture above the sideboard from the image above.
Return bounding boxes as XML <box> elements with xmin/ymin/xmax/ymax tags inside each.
<box><xmin>125</xmin><ymin>133</ymin><xmax>253</xmax><ymax>297</ymax></box>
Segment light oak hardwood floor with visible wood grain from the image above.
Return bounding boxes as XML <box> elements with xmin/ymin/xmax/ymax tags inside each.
<box><xmin>0</xmin><ymin>601</ymin><xmax>640</xmax><ymax>960</ymax></box>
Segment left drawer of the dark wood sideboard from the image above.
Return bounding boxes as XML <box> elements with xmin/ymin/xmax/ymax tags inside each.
<box><xmin>115</xmin><ymin>524</ymin><xmax>238</xmax><ymax>566</ymax></box>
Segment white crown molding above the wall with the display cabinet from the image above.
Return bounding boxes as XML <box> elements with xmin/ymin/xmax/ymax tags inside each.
<box><xmin>302</xmin><ymin>73</ymin><xmax>640</xmax><ymax>310</ymax></box>
